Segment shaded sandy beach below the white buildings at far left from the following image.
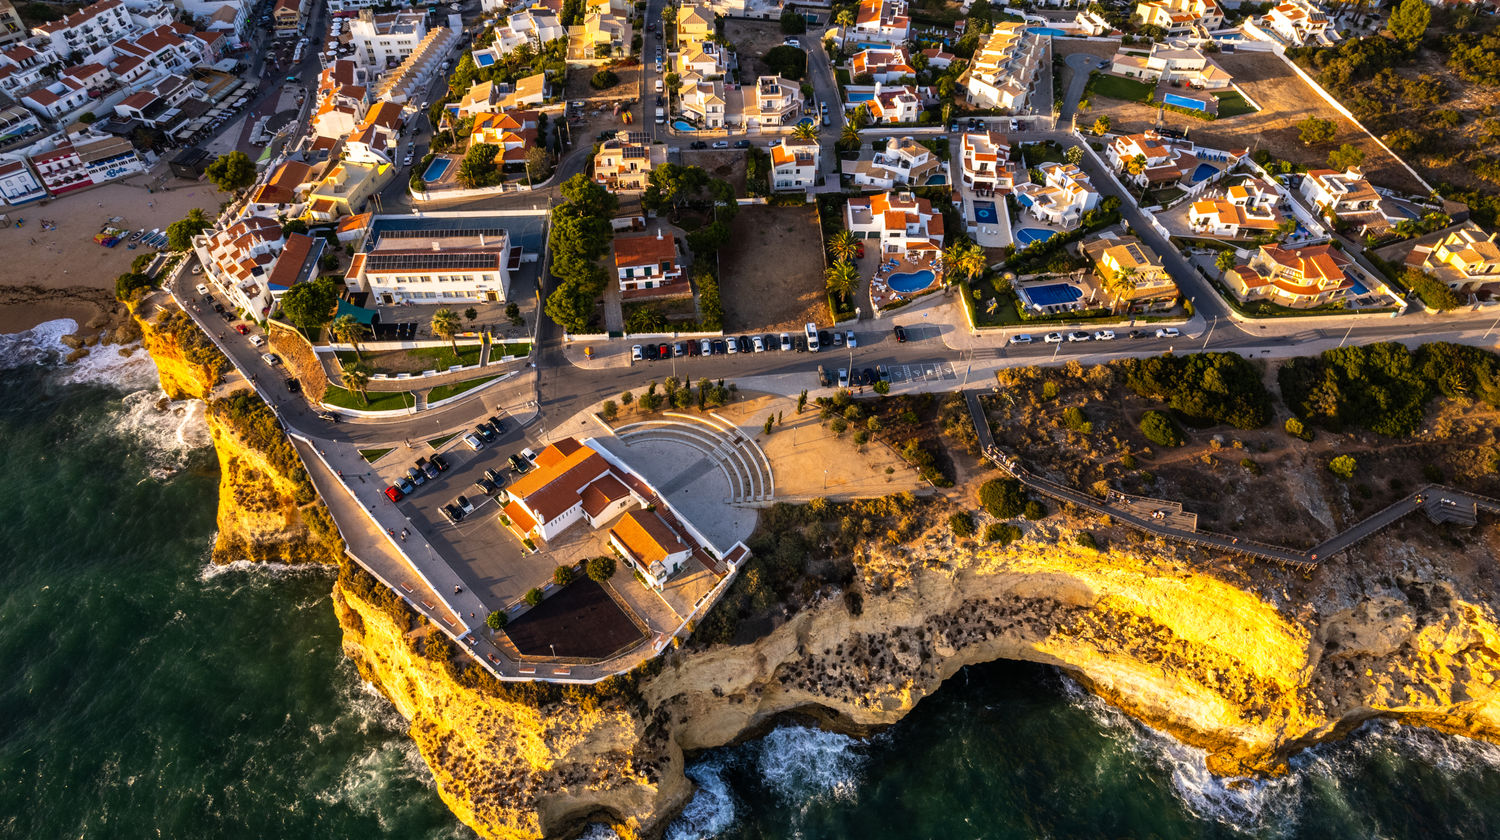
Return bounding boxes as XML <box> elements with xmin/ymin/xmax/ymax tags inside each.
<box><xmin>0</xmin><ymin>172</ymin><xmax>225</xmax><ymax>333</ymax></box>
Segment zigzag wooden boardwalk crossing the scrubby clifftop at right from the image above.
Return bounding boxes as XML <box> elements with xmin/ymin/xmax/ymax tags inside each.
<box><xmin>965</xmin><ymin>390</ymin><xmax>1500</xmax><ymax>569</ymax></box>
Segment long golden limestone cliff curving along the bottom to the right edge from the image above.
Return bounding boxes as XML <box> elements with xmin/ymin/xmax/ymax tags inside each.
<box><xmin>336</xmin><ymin>516</ymin><xmax>1500</xmax><ymax>839</ymax></box>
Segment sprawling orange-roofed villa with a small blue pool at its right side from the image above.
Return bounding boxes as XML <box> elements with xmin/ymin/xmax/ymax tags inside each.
<box><xmin>1224</xmin><ymin>245</ymin><xmax>1368</xmax><ymax>309</ymax></box>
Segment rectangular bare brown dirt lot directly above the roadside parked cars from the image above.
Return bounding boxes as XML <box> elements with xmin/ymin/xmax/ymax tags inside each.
<box><xmin>719</xmin><ymin>206</ymin><xmax>833</xmax><ymax>333</ymax></box>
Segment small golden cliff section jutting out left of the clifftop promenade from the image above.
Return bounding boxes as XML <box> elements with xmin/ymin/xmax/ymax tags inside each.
<box><xmin>205</xmin><ymin>393</ymin><xmax>344</xmax><ymax>564</ymax></box>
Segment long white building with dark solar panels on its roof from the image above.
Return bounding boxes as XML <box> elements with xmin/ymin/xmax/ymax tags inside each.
<box><xmin>344</xmin><ymin>219</ymin><xmax>525</xmax><ymax>306</ymax></box>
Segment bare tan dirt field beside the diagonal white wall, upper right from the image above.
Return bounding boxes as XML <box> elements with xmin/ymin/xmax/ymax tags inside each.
<box><xmin>1080</xmin><ymin>53</ymin><xmax>1427</xmax><ymax>195</ymax></box>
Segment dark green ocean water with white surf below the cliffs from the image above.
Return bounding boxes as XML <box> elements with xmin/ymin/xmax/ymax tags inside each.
<box><xmin>0</xmin><ymin>323</ymin><xmax>1500</xmax><ymax>840</ymax></box>
